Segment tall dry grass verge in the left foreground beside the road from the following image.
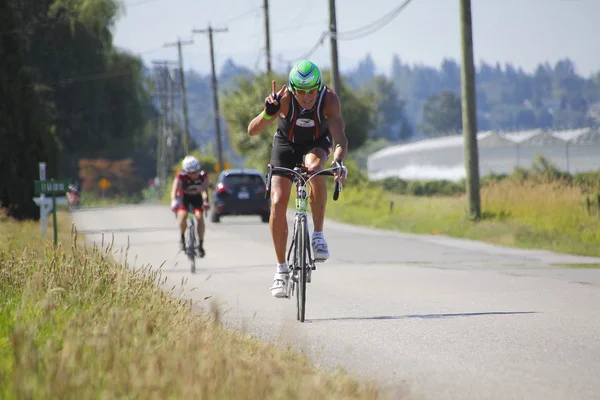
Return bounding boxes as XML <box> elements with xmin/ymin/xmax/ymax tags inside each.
<box><xmin>0</xmin><ymin>213</ymin><xmax>381</xmax><ymax>399</ymax></box>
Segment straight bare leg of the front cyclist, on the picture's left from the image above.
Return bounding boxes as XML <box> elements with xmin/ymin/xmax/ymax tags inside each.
<box><xmin>269</xmin><ymin>175</ymin><xmax>292</xmax><ymax>264</ymax></box>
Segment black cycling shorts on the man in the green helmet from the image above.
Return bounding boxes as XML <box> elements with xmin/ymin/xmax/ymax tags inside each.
<box><xmin>271</xmin><ymin>135</ymin><xmax>331</xmax><ymax>178</ymax></box>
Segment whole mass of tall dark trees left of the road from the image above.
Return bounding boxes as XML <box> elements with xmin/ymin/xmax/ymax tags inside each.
<box><xmin>0</xmin><ymin>0</ymin><xmax>154</xmax><ymax>218</ymax></box>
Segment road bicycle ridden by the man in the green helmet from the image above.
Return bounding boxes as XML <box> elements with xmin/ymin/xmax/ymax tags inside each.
<box><xmin>265</xmin><ymin>164</ymin><xmax>343</xmax><ymax>322</ymax></box>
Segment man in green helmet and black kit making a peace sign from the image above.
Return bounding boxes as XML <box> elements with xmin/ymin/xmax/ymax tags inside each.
<box><xmin>248</xmin><ymin>60</ymin><xmax>348</xmax><ymax>297</ymax></box>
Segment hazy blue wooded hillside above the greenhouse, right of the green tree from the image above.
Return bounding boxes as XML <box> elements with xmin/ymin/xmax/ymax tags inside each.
<box><xmin>348</xmin><ymin>55</ymin><xmax>600</xmax><ymax>140</ymax></box>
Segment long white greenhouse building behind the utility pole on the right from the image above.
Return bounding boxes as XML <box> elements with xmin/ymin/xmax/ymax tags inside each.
<box><xmin>367</xmin><ymin>128</ymin><xmax>600</xmax><ymax>181</ymax></box>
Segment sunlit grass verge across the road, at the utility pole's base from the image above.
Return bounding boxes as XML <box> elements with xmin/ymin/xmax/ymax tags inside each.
<box><xmin>327</xmin><ymin>180</ymin><xmax>600</xmax><ymax>257</ymax></box>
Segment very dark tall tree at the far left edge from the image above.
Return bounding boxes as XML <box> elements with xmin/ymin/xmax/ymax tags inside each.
<box><xmin>0</xmin><ymin>0</ymin><xmax>56</xmax><ymax>219</ymax></box>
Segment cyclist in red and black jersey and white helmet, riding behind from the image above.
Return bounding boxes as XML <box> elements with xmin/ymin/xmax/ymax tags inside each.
<box><xmin>171</xmin><ymin>156</ymin><xmax>210</xmax><ymax>257</ymax></box>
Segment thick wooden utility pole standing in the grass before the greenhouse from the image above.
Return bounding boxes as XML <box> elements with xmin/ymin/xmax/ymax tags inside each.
<box><xmin>459</xmin><ymin>0</ymin><xmax>481</xmax><ymax>220</ymax></box>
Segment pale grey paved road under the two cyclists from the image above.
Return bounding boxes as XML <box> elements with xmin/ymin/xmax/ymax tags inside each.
<box><xmin>74</xmin><ymin>206</ymin><xmax>600</xmax><ymax>400</ymax></box>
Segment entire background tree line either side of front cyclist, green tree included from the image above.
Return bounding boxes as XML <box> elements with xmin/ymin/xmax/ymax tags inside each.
<box><xmin>188</xmin><ymin>55</ymin><xmax>600</xmax><ymax>169</ymax></box>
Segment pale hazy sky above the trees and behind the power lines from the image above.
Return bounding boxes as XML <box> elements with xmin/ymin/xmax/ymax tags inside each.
<box><xmin>114</xmin><ymin>0</ymin><xmax>600</xmax><ymax>76</ymax></box>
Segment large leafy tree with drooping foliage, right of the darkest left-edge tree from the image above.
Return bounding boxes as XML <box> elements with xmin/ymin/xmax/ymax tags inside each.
<box><xmin>19</xmin><ymin>0</ymin><xmax>150</xmax><ymax>175</ymax></box>
